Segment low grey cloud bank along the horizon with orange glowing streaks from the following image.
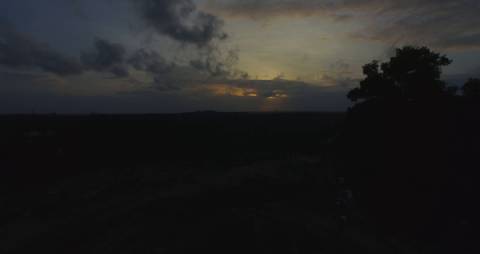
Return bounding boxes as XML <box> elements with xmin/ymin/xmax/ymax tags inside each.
<box><xmin>0</xmin><ymin>71</ymin><xmax>350</xmax><ymax>113</ymax></box>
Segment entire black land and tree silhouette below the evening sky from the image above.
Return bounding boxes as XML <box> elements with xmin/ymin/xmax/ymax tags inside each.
<box><xmin>0</xmin><ymin>47</ymin><xmax>480</xmax><ymax>254</ymax></box>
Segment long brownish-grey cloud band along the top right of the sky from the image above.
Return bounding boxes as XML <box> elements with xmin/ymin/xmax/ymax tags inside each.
<box><xmin>207</xmin><ymin>0</ymin><xmax>480</xmax><ymax>49</ymax></box>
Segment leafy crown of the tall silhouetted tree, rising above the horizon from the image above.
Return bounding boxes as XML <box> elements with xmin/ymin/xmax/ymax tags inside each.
<box><xmin>348</xmin><ymin>46</ymin><xmax>452</xmax><ymax>102</ymax></box>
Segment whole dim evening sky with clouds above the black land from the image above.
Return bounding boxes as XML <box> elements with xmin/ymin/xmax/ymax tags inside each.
<box><xmin>0</xmin><ymin>0</ymin><xmax>480</xmax><ymax>113</ymax></box>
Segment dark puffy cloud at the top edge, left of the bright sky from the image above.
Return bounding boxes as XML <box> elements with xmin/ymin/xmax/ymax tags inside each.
<box><xmin>131</xmin><ymin>0</ymin><xmax>227</xmax><ymax>47</ymax></box>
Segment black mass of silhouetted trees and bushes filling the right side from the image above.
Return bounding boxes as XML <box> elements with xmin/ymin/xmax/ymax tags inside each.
<box><xmin>336</xmin><ymin>46</ymin><xmax>480</xmax><ymax>253</ymax></box>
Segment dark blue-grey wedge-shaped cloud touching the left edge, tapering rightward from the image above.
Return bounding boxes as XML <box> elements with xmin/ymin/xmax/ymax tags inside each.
<box><xmin>0</xmin><ymin>21</ymin><xmax>83</xmax><ymax>76</ymax></box>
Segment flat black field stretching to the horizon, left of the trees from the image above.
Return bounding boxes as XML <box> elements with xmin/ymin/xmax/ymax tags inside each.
<box><xmin>0</xmin><ymin>112</ymin><xmax>368</xmax><ymax>253</ymax></box>
